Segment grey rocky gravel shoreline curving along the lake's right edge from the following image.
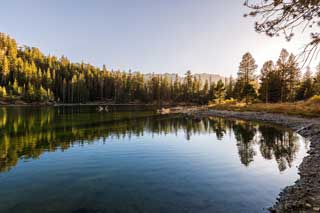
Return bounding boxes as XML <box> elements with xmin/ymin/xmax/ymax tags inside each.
<box><xmin>181</xmin><ymin>109</ymin><xmax>320</xmax><ymax>212</ymax></box>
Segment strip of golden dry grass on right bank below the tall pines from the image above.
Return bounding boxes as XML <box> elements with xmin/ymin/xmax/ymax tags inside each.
<box><xmin>209</xmin><ymin>96</ymin><xmax>320</xmax><ymax>117</ymax></box>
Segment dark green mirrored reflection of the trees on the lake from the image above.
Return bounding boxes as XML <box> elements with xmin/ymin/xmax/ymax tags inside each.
<box><xmin>0</xmin><ymin>107</ymin><xmax>299</xmax><ymax>172</ymax></box>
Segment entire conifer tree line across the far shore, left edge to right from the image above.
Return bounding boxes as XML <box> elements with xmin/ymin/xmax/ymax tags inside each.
<box><xmin>0</xmin><ymin>33</ymin><xmax>320</xmax><ymax>104</ymax></box>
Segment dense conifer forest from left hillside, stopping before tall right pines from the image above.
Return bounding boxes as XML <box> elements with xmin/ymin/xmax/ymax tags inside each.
<box><xmin>0</xmin><ymin>33</ymin><xmax>223</xmax><ymax>103</ymax></box>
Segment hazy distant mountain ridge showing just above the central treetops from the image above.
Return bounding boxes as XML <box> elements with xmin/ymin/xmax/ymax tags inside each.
<box><xmin>144</xmin><ymin>73</ymin><xmax>226</xmax><ymax>84</ymax></box>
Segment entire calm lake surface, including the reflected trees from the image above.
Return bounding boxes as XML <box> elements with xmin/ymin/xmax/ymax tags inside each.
<box><xmin>0</xmin><ymin>107</ymin><xmax>308</xmax><ymax>213</ymax></box>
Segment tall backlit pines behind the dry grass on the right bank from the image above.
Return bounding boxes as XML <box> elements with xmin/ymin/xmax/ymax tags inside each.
<box><xmin>233</xmin><ymin>49</ymin><xmax>320</xmax><ymax>103</ymax></box>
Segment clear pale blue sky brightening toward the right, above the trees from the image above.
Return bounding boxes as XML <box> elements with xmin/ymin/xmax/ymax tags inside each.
<box><xmin>0</xmin><ymin>0</ymin><xmax>308</xmax><ymax>76</ymax></box>
